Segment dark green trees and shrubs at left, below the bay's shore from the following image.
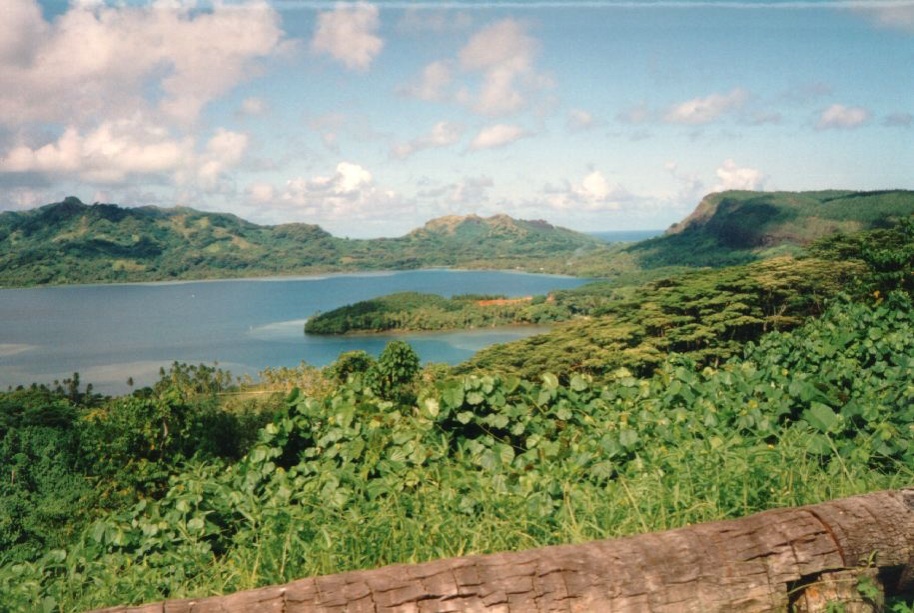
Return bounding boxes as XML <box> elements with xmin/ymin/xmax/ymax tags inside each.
<box><xmin>0</xmin><ymin>364</ymin><xmax>275</xmax><ymax>568</ymax></box>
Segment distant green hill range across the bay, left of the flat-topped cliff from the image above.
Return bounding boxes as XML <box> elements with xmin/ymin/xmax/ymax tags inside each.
<box><xmin>0</xmin><ymin>197</ymin><xmax>601</xmax><ymax>287</ymax></box>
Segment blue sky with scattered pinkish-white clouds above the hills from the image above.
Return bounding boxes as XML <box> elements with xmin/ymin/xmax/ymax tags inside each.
<box><xmin>0</xmin><ymin>0</ymin><xmax>914</xmax><ymax>238</ymax></box>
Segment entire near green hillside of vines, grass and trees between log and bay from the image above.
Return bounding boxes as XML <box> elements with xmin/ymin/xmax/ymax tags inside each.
<box><xmin>0</xmin><ymin>210</ymin><xmax>914</xmax><ymax>611</ymax></box>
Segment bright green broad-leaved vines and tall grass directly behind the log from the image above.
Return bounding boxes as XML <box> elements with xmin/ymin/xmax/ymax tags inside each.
<box><xmin>0</xmin><ymin>294</ymin><xmax>914</xmax><ymax>611</ymax></box>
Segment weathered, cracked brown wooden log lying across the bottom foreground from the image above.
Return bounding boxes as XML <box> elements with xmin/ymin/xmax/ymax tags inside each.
<box><xmin>91</xmin><ymin>489</ymin><xmax>914</xmax><ymax>613</ymax></box>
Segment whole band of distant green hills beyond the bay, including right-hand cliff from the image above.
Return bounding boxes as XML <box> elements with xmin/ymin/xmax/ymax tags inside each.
<box><xmin>0</xmin><ymin>190</ymin><xmax>914</xmax><ymax>287</ymax></box>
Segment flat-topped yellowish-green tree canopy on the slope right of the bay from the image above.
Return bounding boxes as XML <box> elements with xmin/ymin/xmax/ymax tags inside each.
<box><xmin>461</xmin><ymin>257</ymin><xmax>864</xmax><ymax>379</ymax></box>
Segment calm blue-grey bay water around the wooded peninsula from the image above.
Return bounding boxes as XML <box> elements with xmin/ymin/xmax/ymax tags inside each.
<box><xmin>0</xmin><ymin>270</ymin><xmax>585</xmax><ymax>394</ymax></box>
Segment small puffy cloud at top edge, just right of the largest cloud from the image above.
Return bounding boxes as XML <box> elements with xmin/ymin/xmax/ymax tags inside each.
<box><xmin>311</xmin><ymin>2</ymin><xmax>384</xmax><ymax>71</ymax></box>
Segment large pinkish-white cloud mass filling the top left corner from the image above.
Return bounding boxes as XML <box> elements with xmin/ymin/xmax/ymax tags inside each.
<box><xmin>0</xmin><ymin>0</ymin><xmax>283</xmax><ymax>128</ymax></box>
